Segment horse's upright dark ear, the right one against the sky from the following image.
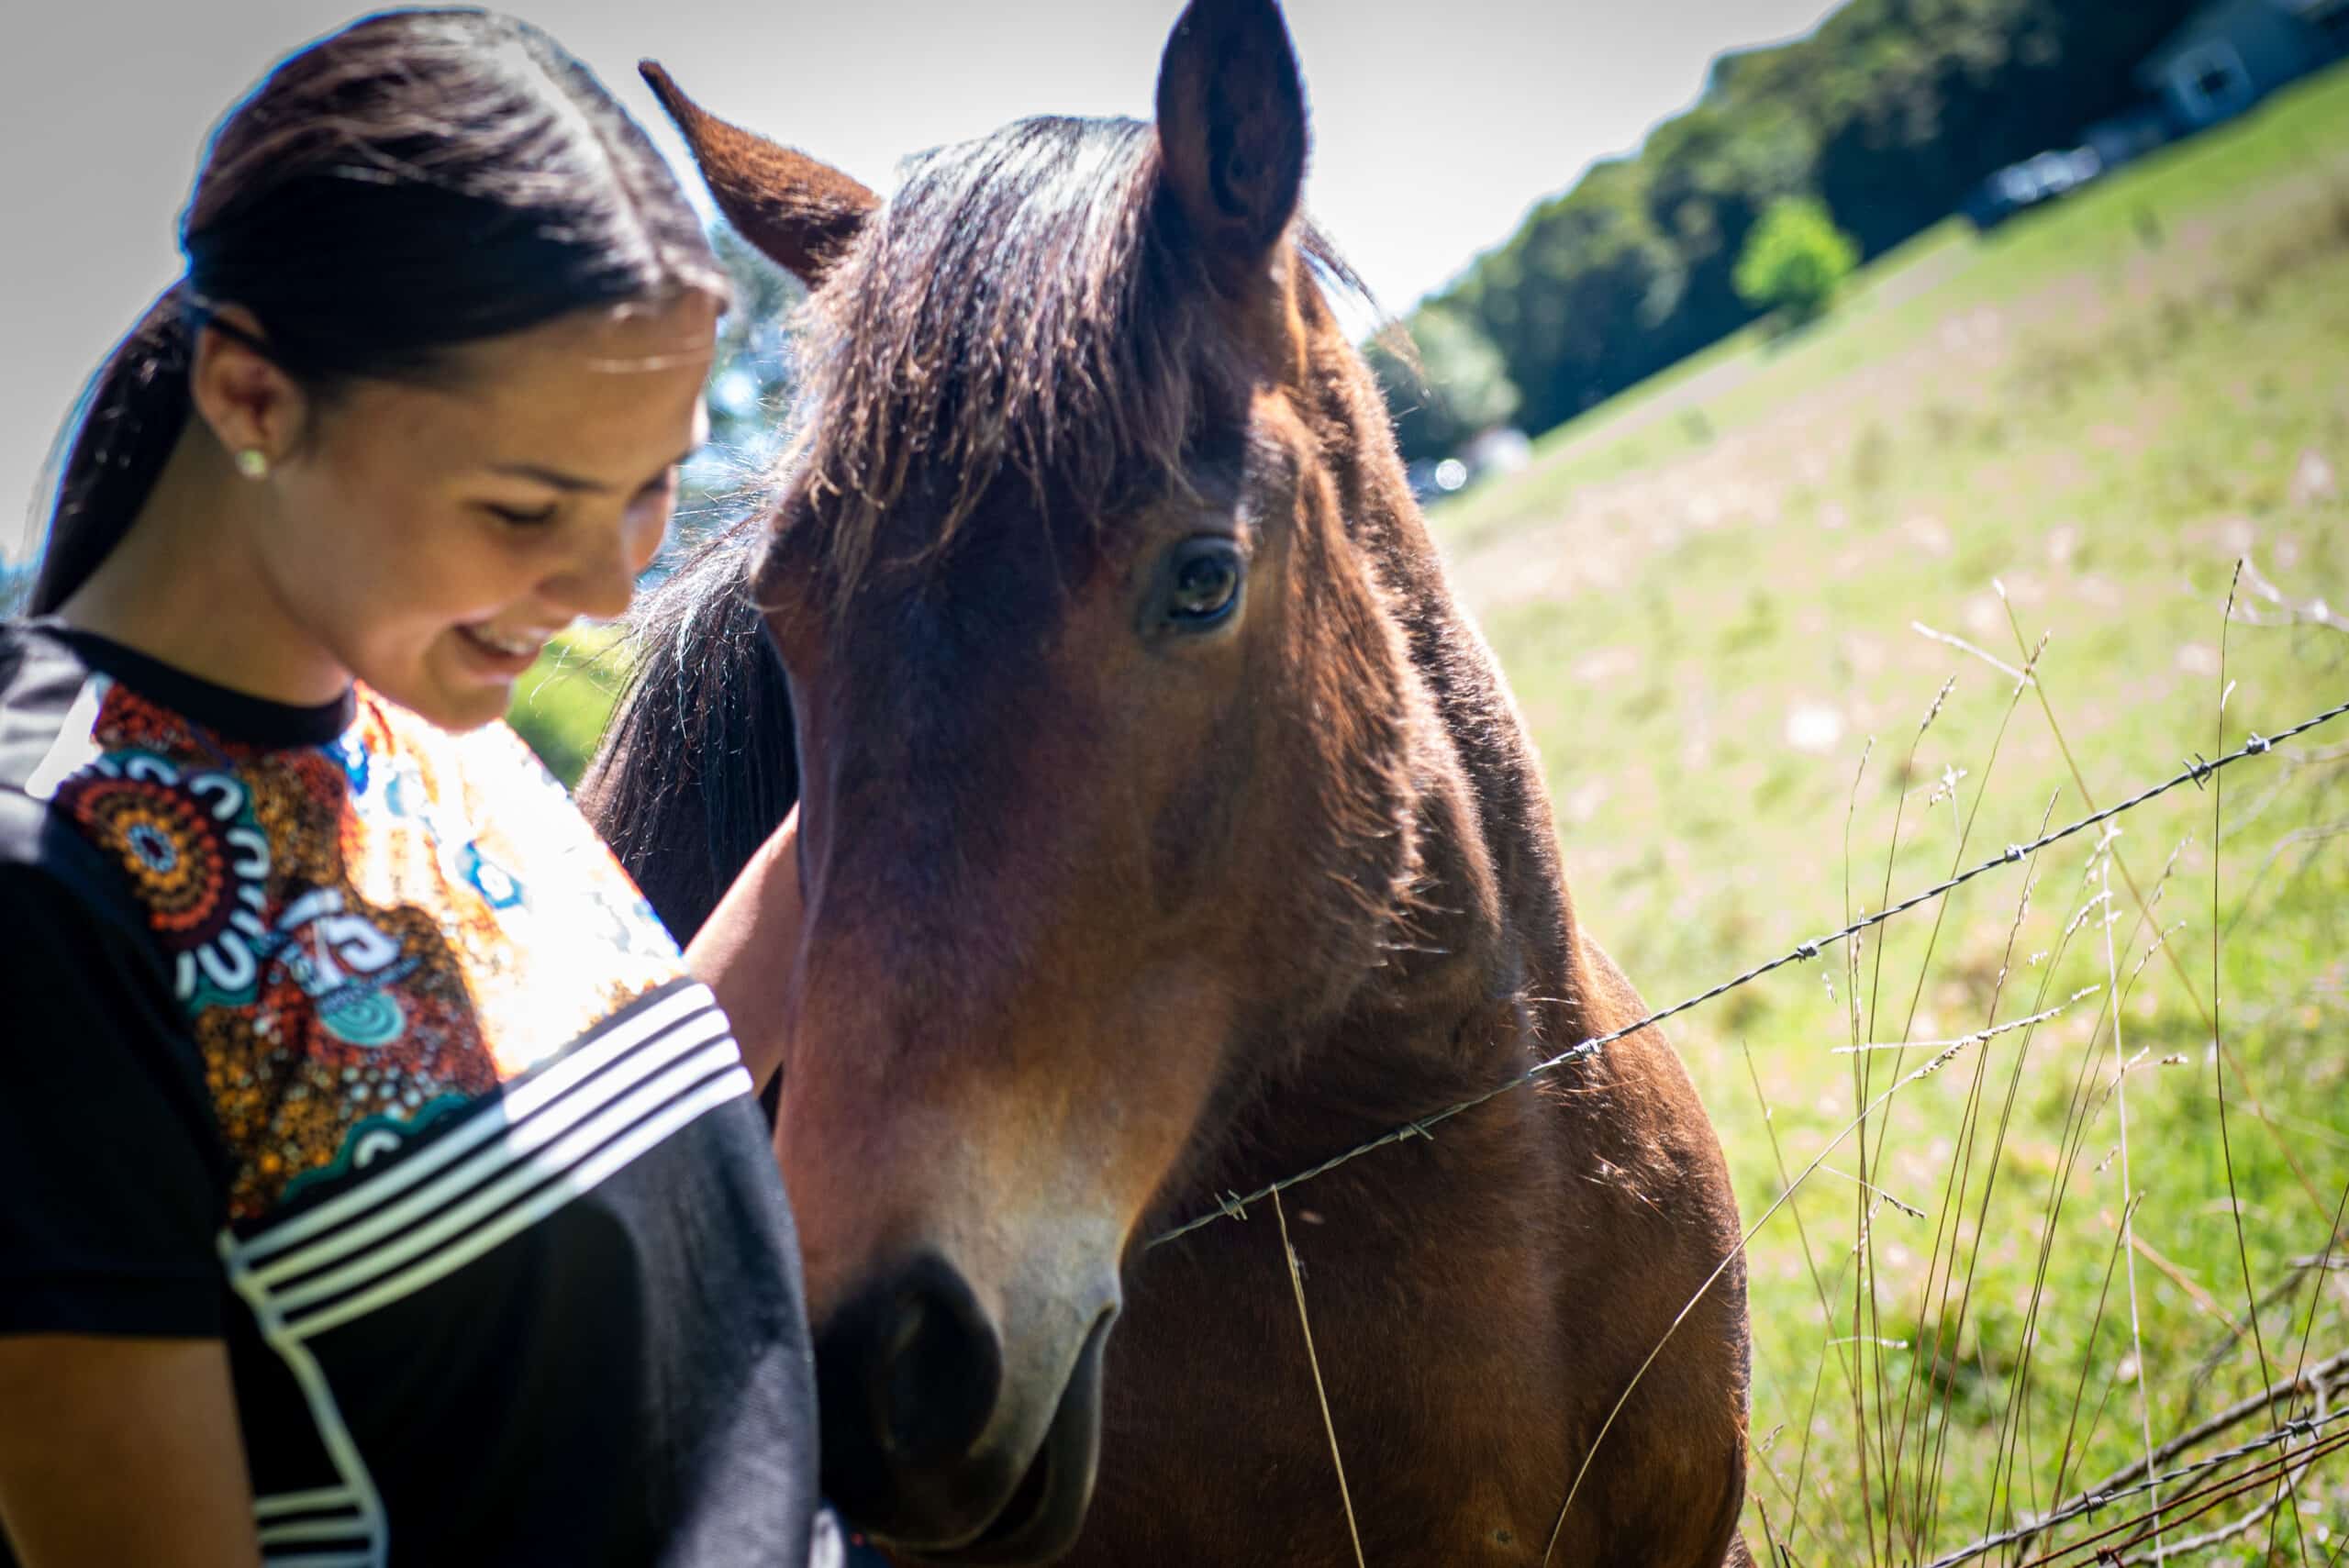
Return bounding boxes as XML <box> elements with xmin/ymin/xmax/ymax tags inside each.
<box><xmin>1158</xmin><ymin>0</ymin><xmax>1306</xmax><ymax>289</ymax></box>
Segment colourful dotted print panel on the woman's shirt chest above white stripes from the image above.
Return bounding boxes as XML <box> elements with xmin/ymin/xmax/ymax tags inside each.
<box><xmin>51</xmin><ymin>676</ymin><xmax>684</xmax><ymax>1230</ymax></box>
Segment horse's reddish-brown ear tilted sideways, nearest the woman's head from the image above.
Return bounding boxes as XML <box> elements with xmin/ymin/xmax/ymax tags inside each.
<box><xmin>637</xmin><ymin>61</ymin><xmax>881</xmax><ymax>289</ymax></box>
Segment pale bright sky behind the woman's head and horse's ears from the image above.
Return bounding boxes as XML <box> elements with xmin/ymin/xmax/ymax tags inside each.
<box><xmin>0</xmin><ymin>0</ymin><xmax>1834</xmax><ymax>554</ymax></box>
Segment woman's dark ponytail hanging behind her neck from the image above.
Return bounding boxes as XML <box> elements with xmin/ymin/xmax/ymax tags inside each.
<box><xmin>26</xmin><ymin>284</ymin><xmax>190</xmax><ymax>615</ymax></box>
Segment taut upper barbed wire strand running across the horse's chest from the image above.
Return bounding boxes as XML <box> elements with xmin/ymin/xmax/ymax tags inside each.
<box><xmin>1149</xmin><ymin>702</ymin><xmax>2349</xmax><ymax>1247</ymax></box>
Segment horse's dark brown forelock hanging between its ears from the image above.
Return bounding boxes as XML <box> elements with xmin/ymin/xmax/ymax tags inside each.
<box><xmin>794</xmin><ymin>106</ymin><xmax>1360</xmax><ymax>592</ymax></box>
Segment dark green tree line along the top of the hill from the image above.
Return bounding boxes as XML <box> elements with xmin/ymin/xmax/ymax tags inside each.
<box><xmin>1384</xmin><ymin>0</ymin><xmax>2199</xmax><ymax>455</ymax></box>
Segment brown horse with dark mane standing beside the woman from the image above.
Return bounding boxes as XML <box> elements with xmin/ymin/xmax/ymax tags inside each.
<box><xmin>587</xmin><ymin>0</ymin><xmax>1748</xmax><ymax>1568</ymax></box>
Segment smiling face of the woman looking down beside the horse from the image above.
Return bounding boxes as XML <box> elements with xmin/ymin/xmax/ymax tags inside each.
<box><xmin>253</xmin><ymin>294</ymin><xmax>717</xmax><ymax>730</ymax></box>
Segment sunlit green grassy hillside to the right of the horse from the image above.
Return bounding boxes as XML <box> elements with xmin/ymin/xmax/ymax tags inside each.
<box><xmin>1435</xmin><ymin>55</ymin><xmax>2349</xmax><ymax>1563</ymax></box>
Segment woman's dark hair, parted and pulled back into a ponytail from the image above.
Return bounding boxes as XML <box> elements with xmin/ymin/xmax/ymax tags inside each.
<box><xmin>30</xmin><ymin>9</ymin><xmax>729</xmax><ymax>615</ymax></box>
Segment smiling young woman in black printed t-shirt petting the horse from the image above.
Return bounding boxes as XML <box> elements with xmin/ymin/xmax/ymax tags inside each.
<box><xmin>0</xmin><ymin>12</ymin><xmax>815</xmax><ymax>1568</ymax></box>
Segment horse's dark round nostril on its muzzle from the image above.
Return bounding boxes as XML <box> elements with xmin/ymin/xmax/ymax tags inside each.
<box><xmin>872</xmin><ymin>1265</ymin><xmax>1003</xmax><ymax>1464</ymax></box>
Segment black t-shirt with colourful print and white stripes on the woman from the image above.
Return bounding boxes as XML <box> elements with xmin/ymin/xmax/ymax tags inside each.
<box><xmin>0</xmin><ymin>622</ymin><xmax>815</xmax><ymax>1568</ymax></box>
